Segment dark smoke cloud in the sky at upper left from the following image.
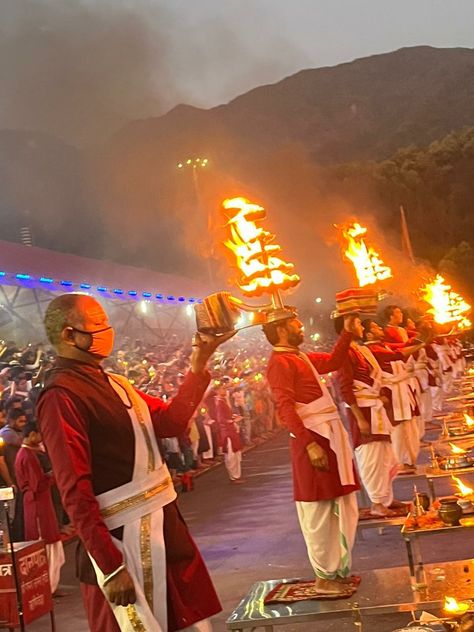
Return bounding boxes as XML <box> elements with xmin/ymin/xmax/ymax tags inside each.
<box><xmin>0</xmin><ymin>0</ymin><xmax>178</xmax><ymax>146</ymax></box>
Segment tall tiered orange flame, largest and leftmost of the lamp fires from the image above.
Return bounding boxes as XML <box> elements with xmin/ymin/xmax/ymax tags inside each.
<box><xmin>222</xmin><ymin>197</ymin><xmax>300</xmax><ymax>296</ymax></box>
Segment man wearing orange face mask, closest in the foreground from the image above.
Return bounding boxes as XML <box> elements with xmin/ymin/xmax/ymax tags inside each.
<box><xmin>38</xmin><ymin>294</ymin><xmax>230</xmax><ymax>632</ymax></box>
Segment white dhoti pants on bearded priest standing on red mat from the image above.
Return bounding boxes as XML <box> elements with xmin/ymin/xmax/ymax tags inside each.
<box><xmin>296</xmin><ymin>492</ymin><xmax>359</xmax><ymax>579</ymax></box>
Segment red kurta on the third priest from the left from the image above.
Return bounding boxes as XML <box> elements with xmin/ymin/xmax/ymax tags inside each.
<box><xmin>337</xmin><ymin>346</ymin><xmax>390</xmax><ymax>449</ymax></box>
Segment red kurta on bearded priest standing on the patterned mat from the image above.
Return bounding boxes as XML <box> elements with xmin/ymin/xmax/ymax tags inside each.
<box><xmin>267</xmin><ymin>331</ymin><xmax>359</xmax><ymax>502</ymax></box>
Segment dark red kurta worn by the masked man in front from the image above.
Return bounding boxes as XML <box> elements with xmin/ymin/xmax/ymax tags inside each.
<box><xmin>37</xmin><ymin>358</ymin><xmax>221</xmax><ymax>632</ymax></box>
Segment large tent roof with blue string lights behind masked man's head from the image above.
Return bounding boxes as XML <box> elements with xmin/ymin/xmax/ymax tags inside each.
<box><xmin>0</xmin><ymin>241</ymin><xmax>205</xmax><ymax>346</ymax></box>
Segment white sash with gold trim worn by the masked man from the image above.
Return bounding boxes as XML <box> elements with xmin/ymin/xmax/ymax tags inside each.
<box><xmin>87</xmin><ymin>375</ymin><xmax>176</xmax><ymax>632</ymax></box>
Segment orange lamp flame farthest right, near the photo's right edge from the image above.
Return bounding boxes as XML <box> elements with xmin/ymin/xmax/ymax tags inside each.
<box><xmin>421</xmin><ymin>274</ymin><xmax>472</xmax><ymax>329</ymax></box>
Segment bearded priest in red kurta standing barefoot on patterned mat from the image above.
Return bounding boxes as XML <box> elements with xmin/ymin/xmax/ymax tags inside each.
<box><xmin>264</xmin><ymin>316</ymin><xmax>359</xmax><ymax>595</ymax></box>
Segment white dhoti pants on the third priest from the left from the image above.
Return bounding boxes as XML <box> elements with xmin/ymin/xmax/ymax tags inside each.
<box><xmin>354</xmin><ymin>441</ymin><xmax>398</xmax><ymax>507</ymax></box>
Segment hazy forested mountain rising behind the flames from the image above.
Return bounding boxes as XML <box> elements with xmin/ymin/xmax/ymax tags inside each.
<box><xmin>0</xmin><ymin>46</ymin><xmax>474</xmax><ymax>291</ymax></box>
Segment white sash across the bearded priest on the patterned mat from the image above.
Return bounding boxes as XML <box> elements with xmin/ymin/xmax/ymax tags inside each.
<box><xmin>295</xmin><ymin>353</ymin><xmax>355</xmax><ymax>485</ymax></box>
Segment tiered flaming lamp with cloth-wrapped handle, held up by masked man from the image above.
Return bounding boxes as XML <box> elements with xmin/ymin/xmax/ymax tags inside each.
<box><xmin>194</xmin><ymin>197</ymin><xmax>300</xmax><ymax>334</ymax></box>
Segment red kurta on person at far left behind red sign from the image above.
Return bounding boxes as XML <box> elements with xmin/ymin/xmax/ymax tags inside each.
<box><xmin>15</xmin><ymin>446</ymin><xmax>61</xmax><ymax>544</ymax></box>
